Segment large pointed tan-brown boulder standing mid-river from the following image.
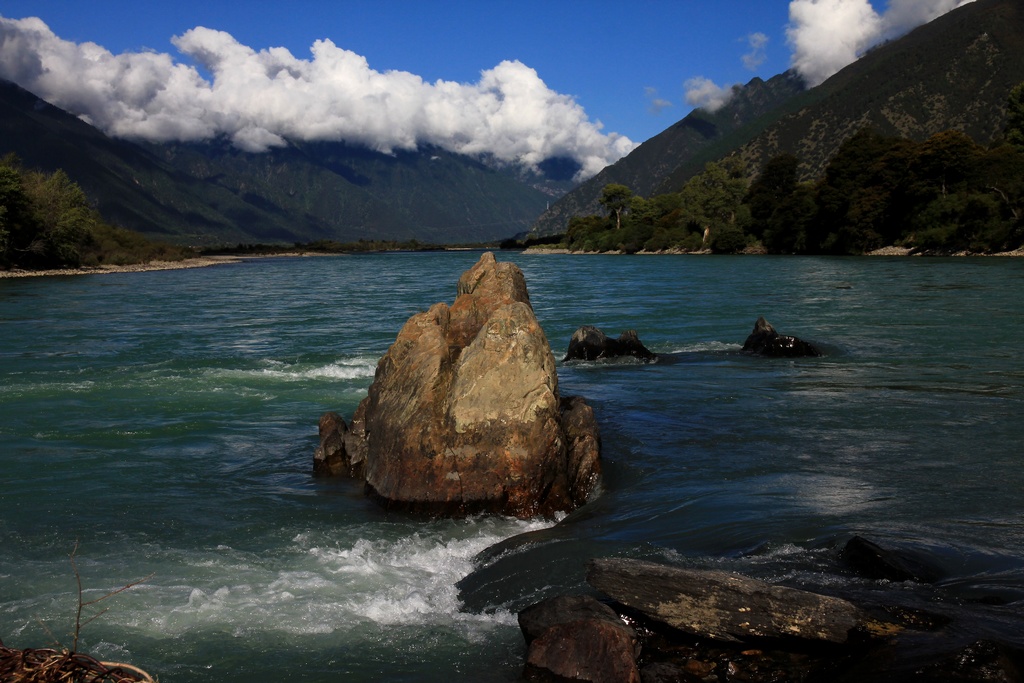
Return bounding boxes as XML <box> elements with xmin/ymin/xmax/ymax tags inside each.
<box><xmin>314</xmin><ymin>253</ymin><xmax>600</xmax><ymax>517</ymax></box>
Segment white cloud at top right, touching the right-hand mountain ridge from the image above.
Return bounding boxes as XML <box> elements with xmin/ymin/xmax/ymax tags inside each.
<box><xmin>786</xmin><ymin>0</ymin><xmax>973</xmax><ymax>86</ymax></box>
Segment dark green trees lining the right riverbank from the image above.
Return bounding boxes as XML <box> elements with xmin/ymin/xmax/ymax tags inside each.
<box><xmin>564</xmin><ymin>84</ymin><xmax>1024</xmax><ymax>254</ymax></box>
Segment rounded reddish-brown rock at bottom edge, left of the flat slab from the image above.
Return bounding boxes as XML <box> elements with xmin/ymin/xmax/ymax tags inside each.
<box><xmin>519</xmin><ymin>595</ymin><xmax>640</xmax><ymax>683</ymax></box>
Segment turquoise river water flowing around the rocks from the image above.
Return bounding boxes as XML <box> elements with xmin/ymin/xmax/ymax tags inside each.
<box><xmin>0</xmin><ymin>252</ymin><xmax>1024</xmax><ymax>683</ymax></box>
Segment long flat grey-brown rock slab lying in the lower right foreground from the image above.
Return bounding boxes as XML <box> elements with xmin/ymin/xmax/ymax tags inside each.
<box><xmin>587</xmin><ymin>558</ymin><xmax>868</xmax><ymax>643</ymax></box>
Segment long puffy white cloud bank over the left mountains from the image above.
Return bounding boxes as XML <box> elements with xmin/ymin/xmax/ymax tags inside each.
<box><xmin>0</xmin><ymin>17</ymin><xmax>636</xmax><ymax>178</ymax></box>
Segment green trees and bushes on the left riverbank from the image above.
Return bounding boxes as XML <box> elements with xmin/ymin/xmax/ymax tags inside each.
<box><xmin>0</xmin><ymin>155</ymin><xmax>190</xmax><ymax>269</ymax></box>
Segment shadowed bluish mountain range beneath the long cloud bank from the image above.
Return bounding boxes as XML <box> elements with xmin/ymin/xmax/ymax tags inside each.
<box><xmin>0</xmin><ymin>82</ymin><xmax>572</xmax><ymax>245</ymax></box>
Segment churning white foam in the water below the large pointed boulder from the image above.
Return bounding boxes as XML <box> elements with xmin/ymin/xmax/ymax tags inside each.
<box><xmin>97</xmin><ymin>517</ymin><xmax>553</xmax><ymax>641</ymax></box>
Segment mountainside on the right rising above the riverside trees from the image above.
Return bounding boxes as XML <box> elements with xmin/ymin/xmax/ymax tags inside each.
<box><xmin>531</xmin><ymin>0</ymin><xmax>1024</xmax><ymax>236</ymax></box>
